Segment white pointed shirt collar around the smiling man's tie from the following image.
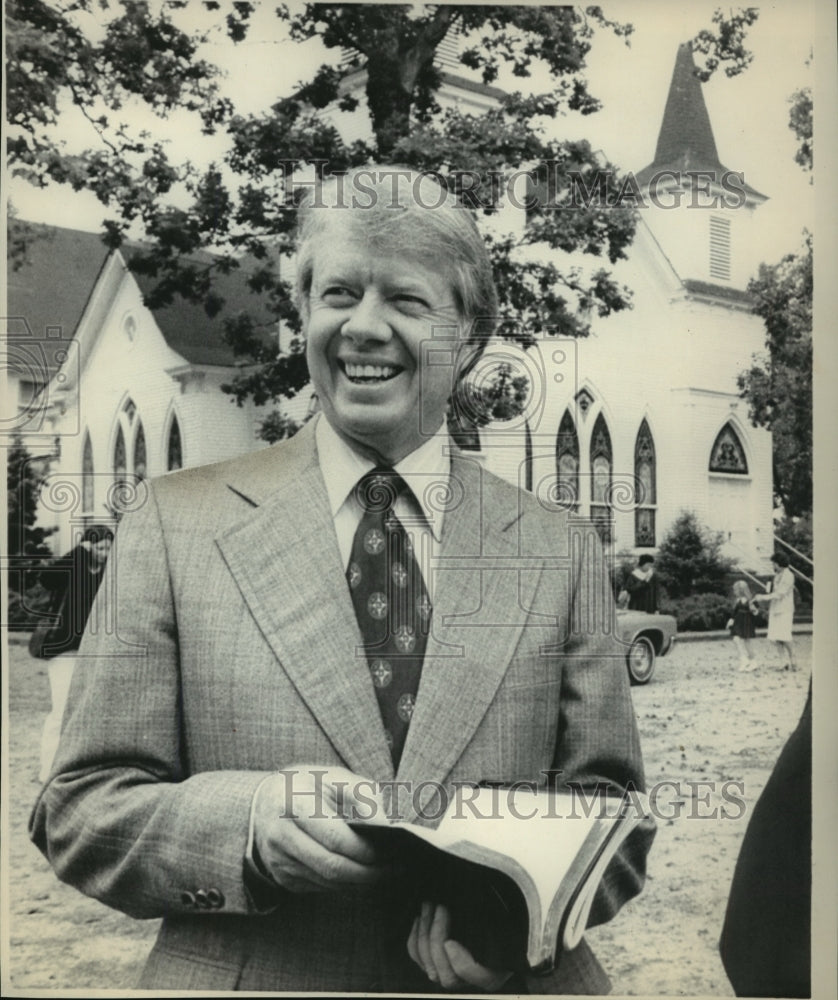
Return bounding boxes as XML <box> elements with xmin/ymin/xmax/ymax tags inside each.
<box><xmin>314</xmin><ymin>414</ymin><xmax>451</xmax><ymax>541</ymax></box>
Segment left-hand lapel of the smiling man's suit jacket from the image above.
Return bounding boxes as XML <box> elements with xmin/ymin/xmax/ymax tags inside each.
<box><xmin>217</xmin><ymin>427</ymin><xmax>393</xmax><ymax>780</ymax></box>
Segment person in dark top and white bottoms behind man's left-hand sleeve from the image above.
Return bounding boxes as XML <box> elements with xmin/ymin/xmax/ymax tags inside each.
<box><xmin>29</xmin><ymin>525</ymin><xmax>113</xmax><ymax>784</ymax></box>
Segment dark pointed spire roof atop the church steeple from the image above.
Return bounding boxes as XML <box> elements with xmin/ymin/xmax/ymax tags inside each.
<box><xmin>635</xmin><ymin>42</ymin><xmax>766</xmax><ymax>201</ymax></box>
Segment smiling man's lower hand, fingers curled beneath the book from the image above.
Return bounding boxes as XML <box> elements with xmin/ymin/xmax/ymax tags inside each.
<box><xmin>407</xmin><ymin>903</ymin><xmax>512</xmax><ymax>993</ymax></box>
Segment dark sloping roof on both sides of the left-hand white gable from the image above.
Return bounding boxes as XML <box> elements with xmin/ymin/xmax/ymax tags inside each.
<box><xmin>8</xmin><ymin>223</ymin><xmax>277</xmax><ymax>375</ymax></box>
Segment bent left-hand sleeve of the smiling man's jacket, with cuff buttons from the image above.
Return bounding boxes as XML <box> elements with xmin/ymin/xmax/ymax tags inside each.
<box><xmin>30</xmin><ymin>487</ymin><xmax>265</xmax><ymax>917</ymax></box>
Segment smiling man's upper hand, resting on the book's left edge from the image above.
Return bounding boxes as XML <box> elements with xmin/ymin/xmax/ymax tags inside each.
<box><xmin>253</xmin><ymin>765</ymin><xmax>385</xmax><ymax>892</ymax></box>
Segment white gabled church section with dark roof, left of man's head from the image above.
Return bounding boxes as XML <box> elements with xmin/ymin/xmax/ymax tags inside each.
<box><xmin>7</xmin><ymin>227</ymin><xmax>276</xmax><ymax>552</ymax></box>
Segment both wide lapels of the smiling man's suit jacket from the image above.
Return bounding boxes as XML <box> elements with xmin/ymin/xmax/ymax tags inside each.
<box><xmin>217</xmin><ymin>425</ymin><xmax>537</xmax><ymax>796</ymax></box>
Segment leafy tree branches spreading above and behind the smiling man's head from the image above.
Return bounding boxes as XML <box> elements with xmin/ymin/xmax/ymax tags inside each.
<box><xmin>6</xmin><ymin>0</ymin><xmax>756</xmax><ymax>434</ymax></box>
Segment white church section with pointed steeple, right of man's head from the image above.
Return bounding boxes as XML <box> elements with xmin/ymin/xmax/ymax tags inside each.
<box><xmin>481</xmin><ymin>44</ymin><xmax>774</xmax><ymax>571</ymax></box>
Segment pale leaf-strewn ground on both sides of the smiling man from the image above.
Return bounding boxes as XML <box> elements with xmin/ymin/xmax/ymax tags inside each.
<box><xmin>3</xmin><ymin>636</ymin><xmax>812</xmax><ymax>996</ymax></box>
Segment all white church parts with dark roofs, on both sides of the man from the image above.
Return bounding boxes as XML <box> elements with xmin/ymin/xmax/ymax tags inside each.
<box><xmin>6</xmin><ymin>45</ymin><xmax>773</xmax><ymax>572</ymax></box>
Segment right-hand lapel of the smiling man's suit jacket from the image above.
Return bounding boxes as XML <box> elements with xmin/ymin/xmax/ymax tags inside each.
<box><xmin>398</xmin><ymin>457</ymin><xmax>538</xmax><ymax>804</ymax></box>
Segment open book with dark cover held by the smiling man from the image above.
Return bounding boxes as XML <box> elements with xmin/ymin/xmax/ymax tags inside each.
<box><xmin>352</xmin><ymin>787</ymin><xmax>649</xmax><ymax>973</ymax></box>
